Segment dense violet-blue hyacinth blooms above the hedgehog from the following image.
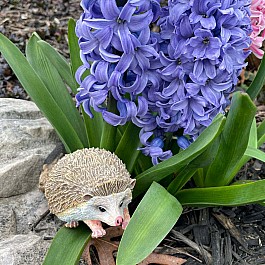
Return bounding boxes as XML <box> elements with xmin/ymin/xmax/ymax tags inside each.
<box><xmin>76</xmin><ymin>0</ymin><xmax>251</xmax><ymax>164</ymax></box>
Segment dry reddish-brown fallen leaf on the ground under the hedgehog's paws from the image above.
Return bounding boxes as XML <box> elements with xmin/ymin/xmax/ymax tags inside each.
<box><xmin>82</xmin><ymin>226</ymin><xmax>186</xmax><ymax>265</ymax></box>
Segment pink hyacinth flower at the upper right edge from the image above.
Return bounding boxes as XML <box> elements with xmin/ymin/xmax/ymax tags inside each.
<box><xmin>250</xmin><ymin>0</ymin><xmax>265</xmax><ymax>59</ymax></box>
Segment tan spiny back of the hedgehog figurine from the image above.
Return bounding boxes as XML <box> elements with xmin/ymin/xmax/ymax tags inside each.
<box><xmin>45</xmin><ymin>148</ymin><xmax>131</xmax><ymax>214</ymax></box>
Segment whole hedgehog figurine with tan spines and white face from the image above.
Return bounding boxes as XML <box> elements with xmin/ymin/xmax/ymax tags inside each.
<box><xmin>40</xmin><ymin>148</ymin><xmax>135</xmax><ymax>238</ymax></box>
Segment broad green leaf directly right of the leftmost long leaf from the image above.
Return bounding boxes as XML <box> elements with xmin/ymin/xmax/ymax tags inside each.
<box><xmin>26</xmin><ymin>34</ymin><xmax>88</xmax><ymax>147</ymax></box>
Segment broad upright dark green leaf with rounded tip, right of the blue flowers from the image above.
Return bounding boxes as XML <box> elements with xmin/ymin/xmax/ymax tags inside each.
<box><xmin>205</xmin><ymin>92</ymin><xmax>256</xmax><ymax>187</ymax></box>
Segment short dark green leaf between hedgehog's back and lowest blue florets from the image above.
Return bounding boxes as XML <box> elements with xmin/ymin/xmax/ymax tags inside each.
<box><xmin>115</xmin><ymin>122</ymin><xmax>140</xmax><ymax>173</ymax></box>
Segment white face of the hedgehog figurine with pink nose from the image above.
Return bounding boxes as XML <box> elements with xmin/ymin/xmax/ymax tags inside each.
<box><xmin>79</xmin><ymin>188</ymin><xmax>132</xmax><ymax>226</ymax></box>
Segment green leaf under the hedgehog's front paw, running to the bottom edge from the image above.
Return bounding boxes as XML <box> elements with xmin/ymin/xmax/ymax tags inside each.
<box><xmin>43</xmin><ymin>223</ymin><xmax>91</xmax><ymax>265</ymax></box>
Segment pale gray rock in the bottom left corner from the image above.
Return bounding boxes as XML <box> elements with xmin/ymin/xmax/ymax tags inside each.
<box><xmin>0</xmin><ymin>234</ymin><xmax>49</xmax><ymax>265</ymax></box>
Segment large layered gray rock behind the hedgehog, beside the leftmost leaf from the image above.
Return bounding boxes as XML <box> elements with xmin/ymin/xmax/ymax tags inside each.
<box><xmin>0</xmin><ymin>98</ymin><xmax>59</xmax><ymax>198</ymax></box>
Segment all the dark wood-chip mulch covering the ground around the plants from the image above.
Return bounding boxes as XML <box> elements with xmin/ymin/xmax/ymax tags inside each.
<box><xmin>0</xmin><ymin>0</ymin><xmax>265</xmax><ymax>265</ymax></box>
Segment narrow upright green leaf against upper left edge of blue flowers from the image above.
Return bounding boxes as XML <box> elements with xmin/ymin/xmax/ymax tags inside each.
<box><xmin>68</xmin><ymin>18</ymin><xmax>83</xmax><ymax>94</ymax></box>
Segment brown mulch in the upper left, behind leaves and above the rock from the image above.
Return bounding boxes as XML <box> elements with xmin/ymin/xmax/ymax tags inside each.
<box><xmin>0</xmin><ymin>0</ymin><xmax>81</xmax><ymax>99</ymax></box>
